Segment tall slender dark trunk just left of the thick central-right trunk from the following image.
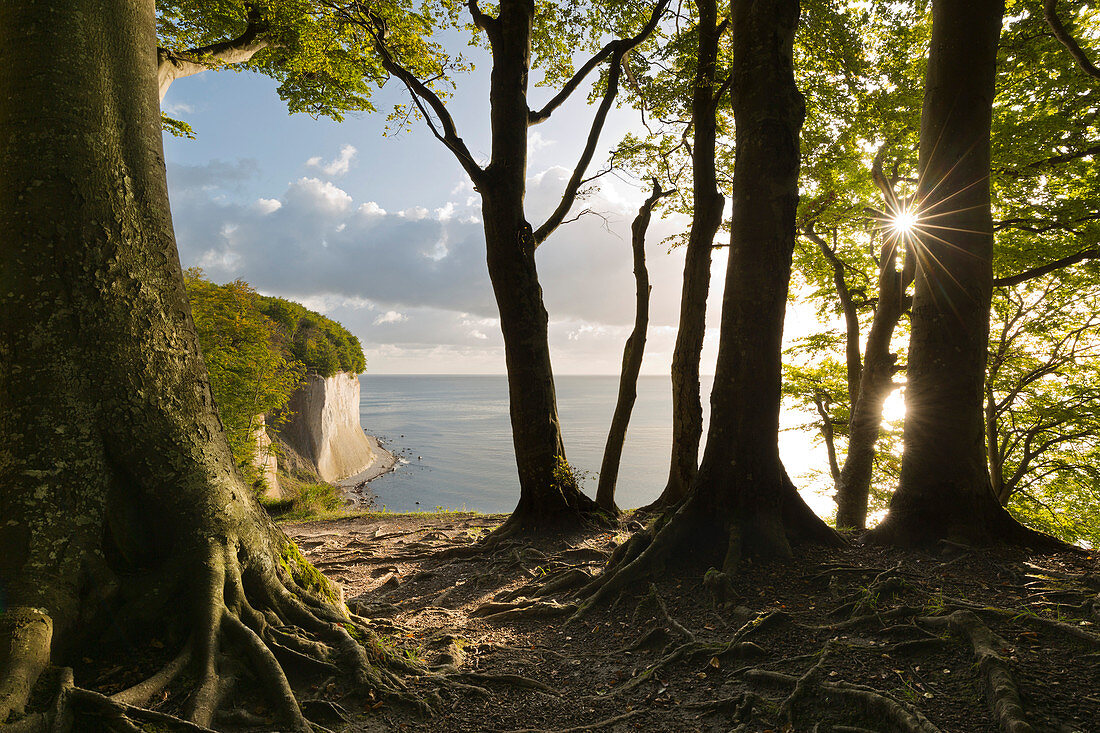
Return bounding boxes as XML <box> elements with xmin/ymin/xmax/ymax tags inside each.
<box><xmin>649</xmin><ymin>0</ymin><xmax>725</xmax><ymax>508</ymax></box>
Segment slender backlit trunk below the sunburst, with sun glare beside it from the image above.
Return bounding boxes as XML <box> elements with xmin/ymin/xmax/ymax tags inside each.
<box><xmin>836</xmin><ymin>242</ymin><xmax>909</xmax><ymax>529</ymax></box>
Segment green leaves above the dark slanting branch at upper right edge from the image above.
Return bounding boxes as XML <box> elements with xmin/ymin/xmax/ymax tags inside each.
<box><xmin>992</xmin><ymin>1</ymin><xmax>1100</xmax><ymax>275</ymax></box>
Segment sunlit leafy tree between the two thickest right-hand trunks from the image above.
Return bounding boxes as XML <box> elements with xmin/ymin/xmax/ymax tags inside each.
<box><xmin>784</xmin><ymin>2</ymin><xmax>930</xmax><ymax>528</ymax></box>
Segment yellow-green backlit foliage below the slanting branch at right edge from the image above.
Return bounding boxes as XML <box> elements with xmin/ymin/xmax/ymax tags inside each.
<box><xmin>987</xmin><ymin>277</ymin><xmax>1100</xmax><ymax>547</ymax></box>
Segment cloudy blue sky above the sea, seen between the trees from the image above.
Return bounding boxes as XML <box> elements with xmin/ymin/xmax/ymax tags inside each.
<box><xmin>163</xmin><ymin>42</ymin><xmax>811</xmax><ymax>374</ymax></box>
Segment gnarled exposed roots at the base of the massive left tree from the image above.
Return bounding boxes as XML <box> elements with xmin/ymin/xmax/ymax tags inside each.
<box><xmin>0</xmin><ymin>530</ymin><xmax>425</xmax><ymax>733</ymax></box>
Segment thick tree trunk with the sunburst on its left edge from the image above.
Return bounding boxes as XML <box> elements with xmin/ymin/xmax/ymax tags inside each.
<box><xmin>871</xmin><ymin>0</ymin><xmax>1056</xmax><ymax>545</ymax></box>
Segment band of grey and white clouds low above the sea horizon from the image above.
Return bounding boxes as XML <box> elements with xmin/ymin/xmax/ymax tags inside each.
<box><xmin>169</xmin><ymin>163</ymin><xmax>725</xmax><ymax>374</ymax></box>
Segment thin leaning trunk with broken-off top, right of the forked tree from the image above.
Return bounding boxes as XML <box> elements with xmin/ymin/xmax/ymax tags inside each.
<box><xmin>596</xmin><ymin>179</ymin><xmax>669</xmax><ymax>514</ymax></box>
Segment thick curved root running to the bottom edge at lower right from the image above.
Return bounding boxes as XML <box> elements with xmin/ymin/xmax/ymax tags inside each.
<box><xmin>920</xmin><ymin>611</ymin><xmax>1033</xmax><ymax>733</ymax></box>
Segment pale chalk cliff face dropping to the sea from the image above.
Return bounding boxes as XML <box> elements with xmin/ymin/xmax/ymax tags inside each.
<box><xmin>278</xmin><ymin>372</ymin><xmax>375</xmax><ymax>481</ymax></box>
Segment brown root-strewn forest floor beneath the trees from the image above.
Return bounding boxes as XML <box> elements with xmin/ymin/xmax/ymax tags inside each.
<box><xmin>284</xmin><ymin>514</ymin><xmax>1100</xmax><ymax>733</ymax></box>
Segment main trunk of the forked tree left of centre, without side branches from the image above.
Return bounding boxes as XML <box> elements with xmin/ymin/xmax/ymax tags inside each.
<box><xmin>479</xmin><ymin>0</ymin><xmax>596</xmax><ymax>533</ymax></box>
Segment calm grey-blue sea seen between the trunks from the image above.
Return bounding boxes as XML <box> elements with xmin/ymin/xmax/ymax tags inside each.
<box><xmin>360</xmin><ymin>374</ymin><xmax>820</xmax><ymax>513</ymax></box>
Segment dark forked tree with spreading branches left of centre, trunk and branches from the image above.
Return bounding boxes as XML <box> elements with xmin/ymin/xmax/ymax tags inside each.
<box><xmin>345</xmin><ymin>0</ymin><xmax>668</xmax><ymax>528</ymax></box>
